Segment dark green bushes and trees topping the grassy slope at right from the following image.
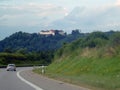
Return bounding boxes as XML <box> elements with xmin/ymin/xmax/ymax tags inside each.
<box><xmin>55</xmin><ymin>31</ymin><xmax>120</xmax><ymax>57</ymax></box>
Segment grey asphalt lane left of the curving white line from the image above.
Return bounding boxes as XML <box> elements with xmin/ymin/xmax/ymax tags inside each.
<box><xmin>0</xmin><ymin>68</ymin><xmax>35</xmax><ymax>90</ymax></box>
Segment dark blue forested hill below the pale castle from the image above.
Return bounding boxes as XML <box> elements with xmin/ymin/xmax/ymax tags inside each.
<box><xmin>0</xmin><ymin>31</ymin><xmax>85</xmax><ymax>52</ymax></box>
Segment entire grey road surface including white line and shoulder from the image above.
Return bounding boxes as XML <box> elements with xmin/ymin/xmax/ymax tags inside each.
<box><xmin>0</xmin><ymin>68</ymin><xmax>89</xmax><ymax>90</ymax></box>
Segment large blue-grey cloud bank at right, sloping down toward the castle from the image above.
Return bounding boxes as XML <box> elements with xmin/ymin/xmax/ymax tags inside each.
<box><xmin>47</xmin><ymin>6</ymin><xmax>120</xmax><ymax>32</ymax></box>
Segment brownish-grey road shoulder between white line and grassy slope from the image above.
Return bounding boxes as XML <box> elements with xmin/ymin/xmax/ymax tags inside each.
<box><xmin>20</xmin><ymin>70</ymin><xmax>89</xmax><ymax>90</ymax></box>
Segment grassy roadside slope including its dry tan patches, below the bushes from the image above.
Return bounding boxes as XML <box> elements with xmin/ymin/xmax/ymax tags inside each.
<box><xmin>34</xmin><ymin>44</ymin><xmax>120</xmax><ymax>90</ymax></box>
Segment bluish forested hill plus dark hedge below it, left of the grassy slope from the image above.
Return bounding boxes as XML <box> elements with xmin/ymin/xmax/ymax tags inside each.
<box><xmin>0</xmin><ymin>31</ymin><xmax>84</xmax><ymax>65</ymax></box>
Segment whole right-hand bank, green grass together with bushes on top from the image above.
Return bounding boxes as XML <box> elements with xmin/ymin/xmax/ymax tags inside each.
<box><xmin>34</xmin><ymin>32</ymin><xmax>120</xmax><ymax>90</ymax></box>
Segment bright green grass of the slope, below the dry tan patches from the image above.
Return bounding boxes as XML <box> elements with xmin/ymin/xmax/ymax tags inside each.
<box><xmin>35</xmin><ymin>54</ymin><xmax>120</xmax><ymax>90</ymax></box>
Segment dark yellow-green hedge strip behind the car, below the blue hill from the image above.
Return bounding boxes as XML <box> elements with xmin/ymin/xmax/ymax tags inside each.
<box><xmin>0</xmin><ymin>49</ymin><xmax>53</xmax><ymax>67</ymax></box>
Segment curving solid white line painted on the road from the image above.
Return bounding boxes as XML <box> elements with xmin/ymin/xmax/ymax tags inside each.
<box><xmin>17</xmin><ymin>70</ymin><xmax>43</xmax><ymax>90</ymax></box>
